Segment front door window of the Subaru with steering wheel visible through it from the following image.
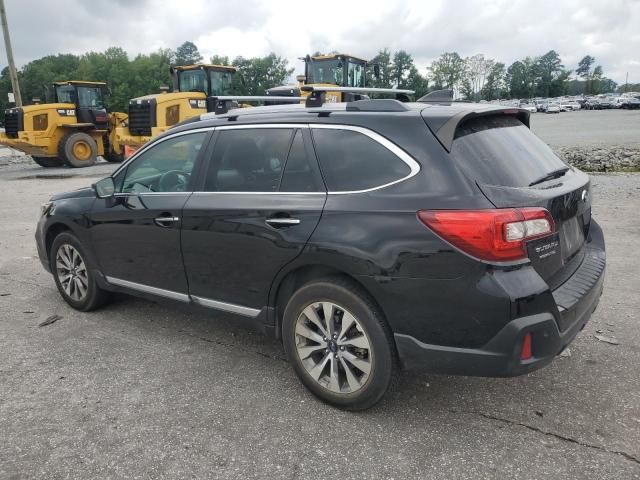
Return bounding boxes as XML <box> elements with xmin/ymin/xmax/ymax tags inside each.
<box><xmin>121</xmin><ymin>132</ymin><xmax>207</xmax><ymax>193</ymax></box>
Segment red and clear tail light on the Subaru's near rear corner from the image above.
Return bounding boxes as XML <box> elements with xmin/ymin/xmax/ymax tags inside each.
<box><xmin>418</xmin><ymin>208</ymin><xmax>555</xmax><ymax>262</ymax></box>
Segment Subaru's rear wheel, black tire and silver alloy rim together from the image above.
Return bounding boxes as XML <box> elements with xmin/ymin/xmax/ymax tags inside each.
<box><xmin>283</xmin><ymin>278</ymin><xmax>397</xmax><ymax>410</ymax></box>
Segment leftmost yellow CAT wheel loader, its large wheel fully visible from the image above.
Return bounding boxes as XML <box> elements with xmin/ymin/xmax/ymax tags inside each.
<box><xmin>0</xmin><ymin>80</ymin><xmax>127</xmax><ymax>167</ymax></box>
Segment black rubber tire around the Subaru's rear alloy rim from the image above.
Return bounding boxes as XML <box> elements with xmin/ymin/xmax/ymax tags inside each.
<box><xmin>282</xmin><ymin>277</ymin><xmax>398</xmax><ymax>411</ymax></box>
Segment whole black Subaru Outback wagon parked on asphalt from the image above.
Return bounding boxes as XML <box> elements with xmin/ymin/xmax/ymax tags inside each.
<box><xmin>36</xmin><ymin>100</ymin><xmax>605</xmax><ymax>410</ymax></box>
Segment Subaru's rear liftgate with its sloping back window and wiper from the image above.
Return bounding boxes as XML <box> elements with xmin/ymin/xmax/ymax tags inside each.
<box><xmin>451</xmin><ymin>115</ymin><xmax>591</xmax><ymax>288</ymax></box>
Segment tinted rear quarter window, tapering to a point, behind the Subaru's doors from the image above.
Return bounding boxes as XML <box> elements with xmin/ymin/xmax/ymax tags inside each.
<box><xmin>313</xmin><ymin>129</ymin><xmax>411</xmax><ymax>192</ymax></box>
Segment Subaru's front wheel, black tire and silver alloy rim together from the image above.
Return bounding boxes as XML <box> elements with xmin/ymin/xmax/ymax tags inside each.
<box><xmin>49</xmin><ymin>232</ymin><xmax>110</xmax><ymax>312</ymax></box>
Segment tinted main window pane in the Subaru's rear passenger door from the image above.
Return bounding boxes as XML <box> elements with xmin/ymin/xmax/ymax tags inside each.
<box><xmin>204</xmin><ymin>128</ymin><xmax>293</xmax><ymax>192</ymax></box>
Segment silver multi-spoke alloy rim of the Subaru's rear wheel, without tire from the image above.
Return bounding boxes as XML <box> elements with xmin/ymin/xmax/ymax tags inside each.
<box><xmin>295</xmin><ymin>301</ymin><xmax>373</xmax><ymax>393</ymax></box>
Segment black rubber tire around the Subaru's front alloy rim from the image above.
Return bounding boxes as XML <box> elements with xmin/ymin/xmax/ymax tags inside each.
<box><xmin>49</xmin><ymin>232</ymin><xmax>111</xmax><ymax>312</ymax></box>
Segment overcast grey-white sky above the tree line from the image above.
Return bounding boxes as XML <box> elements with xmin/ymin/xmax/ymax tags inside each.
<box><xmin>0</xmin><ymin>0</ymin><xmax>640</xmax><ymax>83</ymax></box>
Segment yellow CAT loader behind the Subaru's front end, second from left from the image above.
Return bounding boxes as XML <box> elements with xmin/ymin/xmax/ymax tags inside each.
<box><xmin>115</xmin><ymin>64</ymin><xmax>237</xmax><ymax>152</ymax></box>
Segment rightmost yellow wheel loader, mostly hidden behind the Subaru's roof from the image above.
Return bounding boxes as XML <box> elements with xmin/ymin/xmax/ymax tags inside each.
<box><xmin>267</xmin><ymin>53</ymin><xmax>367</xmax><ymax>103</ymax></box>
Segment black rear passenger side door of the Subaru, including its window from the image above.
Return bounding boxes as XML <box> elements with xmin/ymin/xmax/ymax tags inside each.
<box><xmin>182</xmin><ymin>125</ymin><xmax>326</xmax><ymax>316</ymax></box>
